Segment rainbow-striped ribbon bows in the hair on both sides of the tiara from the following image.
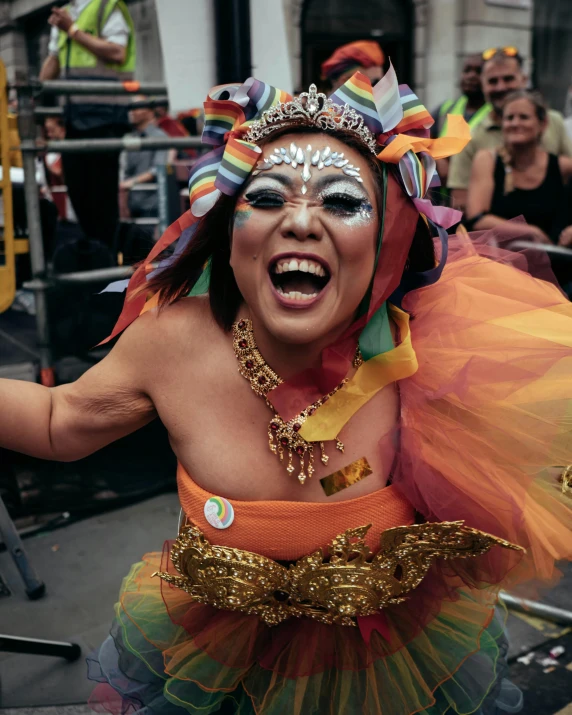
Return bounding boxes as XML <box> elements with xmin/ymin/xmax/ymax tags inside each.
<box><xmin>104</xmin><ymin>65</ymin><xmax>470</xmax><ymax>342</ymax></box>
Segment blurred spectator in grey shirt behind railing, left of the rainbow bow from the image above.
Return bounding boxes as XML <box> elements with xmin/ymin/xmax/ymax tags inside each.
<box><xmin>120</xmin><ymin>97</ymin><xmax>168</xmax><ymax>218</ymax></box>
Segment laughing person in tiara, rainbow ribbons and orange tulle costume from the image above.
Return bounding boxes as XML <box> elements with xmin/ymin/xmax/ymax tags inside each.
<box><xmin>0</xmin><ymin>70</ymin><xmax>572</xmax><ymax>715</ymax></box>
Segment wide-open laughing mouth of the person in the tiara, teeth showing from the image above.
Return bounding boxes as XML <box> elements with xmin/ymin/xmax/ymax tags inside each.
<box><xmin>270</xmin><ymin>256</ymin><xmax>330</xmax><ymax>302</ymax></box>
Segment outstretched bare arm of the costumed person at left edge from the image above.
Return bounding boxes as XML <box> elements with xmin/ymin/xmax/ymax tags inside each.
<box><xmin>0</xmin><ymin>316</ymin><xmax>156</xmax><ymax>461</ymax></box>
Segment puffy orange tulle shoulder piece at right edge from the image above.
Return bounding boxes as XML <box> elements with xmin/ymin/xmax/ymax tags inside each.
<box><xmin>394</xmin><ymin>228</ymin><xmax>572</xmax><ymax>585</ymax></box>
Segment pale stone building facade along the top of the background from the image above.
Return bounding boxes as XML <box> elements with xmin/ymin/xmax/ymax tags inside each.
<box><xmin>0</xmin><ymin>0</ymin><xmax>572</xmax><ymax>114</ymax></box>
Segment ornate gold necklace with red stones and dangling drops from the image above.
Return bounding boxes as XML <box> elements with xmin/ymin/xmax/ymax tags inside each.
<box><xmin>232</xmin><ymin>318</ymin><xmax>363</xmax><ymax>484</ymax></box>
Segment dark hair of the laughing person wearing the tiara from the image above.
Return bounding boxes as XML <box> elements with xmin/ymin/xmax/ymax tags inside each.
<box><xmin>145</xmin><ymin>125</ymin><xmax>435</xmax><ymax>331</ymax></box>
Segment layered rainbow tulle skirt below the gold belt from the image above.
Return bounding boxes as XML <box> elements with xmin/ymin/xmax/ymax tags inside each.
<box><xmin>89</xmin><ymin>553</ymin><xmax>521</xmax><ymax>715</ymax></box>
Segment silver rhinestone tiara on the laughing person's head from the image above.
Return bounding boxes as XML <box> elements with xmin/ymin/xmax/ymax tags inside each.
<box><xmin>244</xmin><ymin>84</ymin><xmax>378</xmax><ymax>154</ymax></box>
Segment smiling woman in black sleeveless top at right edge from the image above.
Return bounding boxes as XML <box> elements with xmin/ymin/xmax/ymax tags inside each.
<box><xmin>467</xmin><ymin>90</ymin><xmax>572</xmax><ymax>243</ymax></box>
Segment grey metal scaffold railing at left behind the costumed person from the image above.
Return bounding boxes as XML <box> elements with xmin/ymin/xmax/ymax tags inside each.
<box><xmin>6</xmin><ymin>72</ymin><xmax>202</xmax><ymax>386</ymax></box>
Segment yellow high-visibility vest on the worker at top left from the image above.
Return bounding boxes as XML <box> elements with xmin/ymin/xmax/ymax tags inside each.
<box><xmin>58</xmin><ymin>0</ymin><xmax>136</xmax><ymax>86</ymax></box>
